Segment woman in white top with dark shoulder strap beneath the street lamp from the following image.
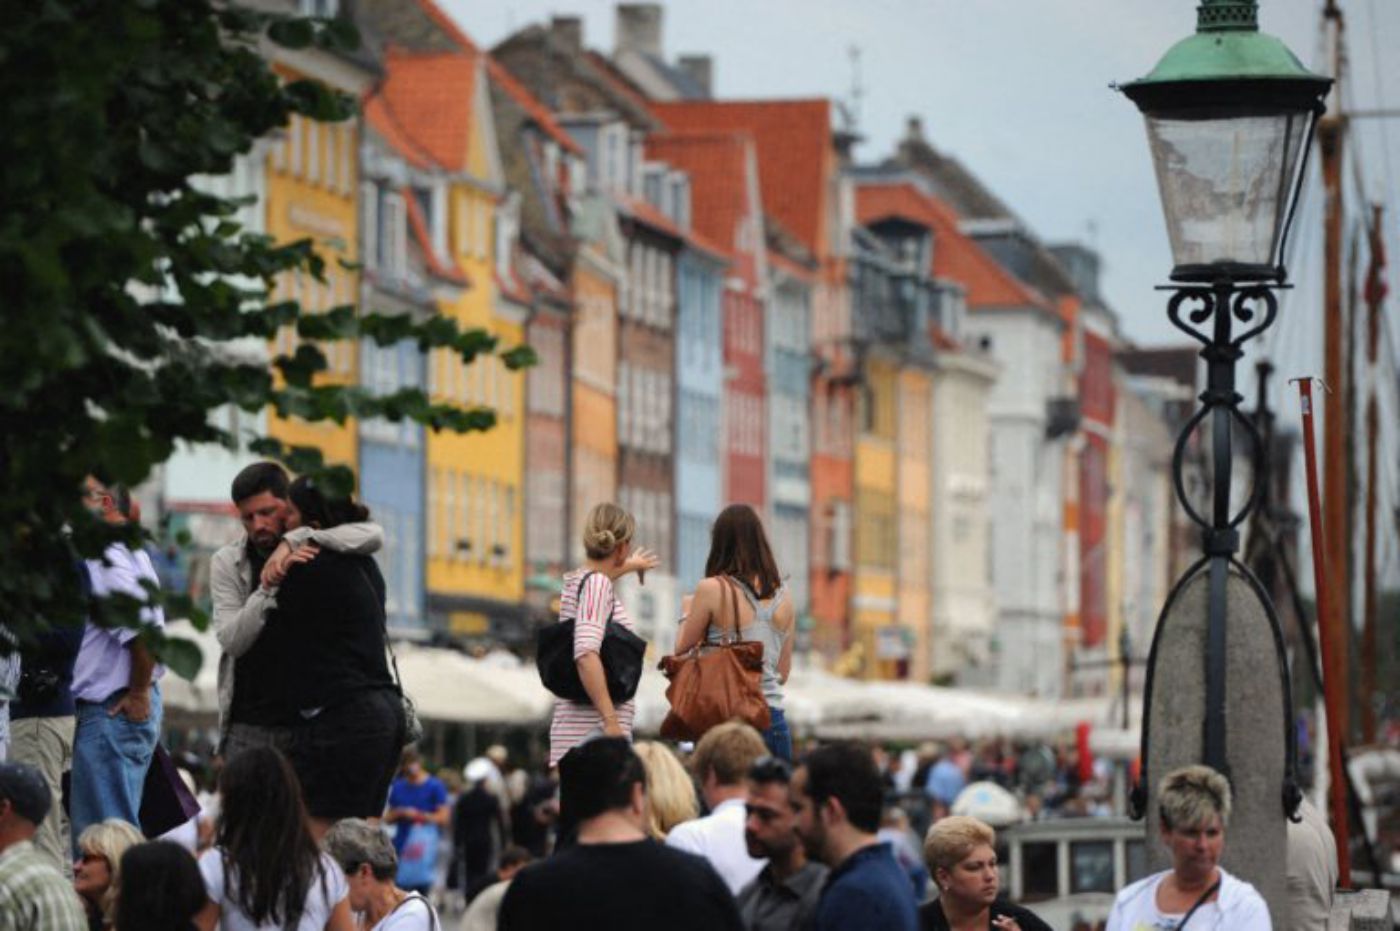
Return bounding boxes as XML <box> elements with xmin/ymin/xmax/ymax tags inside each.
<box><xmin>1107</xmin><ymin>766</ymin><xmax>1281</xmax><ymax>931</ymax></box>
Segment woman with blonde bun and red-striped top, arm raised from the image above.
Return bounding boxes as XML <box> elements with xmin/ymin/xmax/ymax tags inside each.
<box><xmin>549</xmin><ymin>504</ymin><xmax>661</xmax><ymax>766</ymax></box>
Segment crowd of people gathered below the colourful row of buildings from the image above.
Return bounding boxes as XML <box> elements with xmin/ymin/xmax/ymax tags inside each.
<box><xmin>0</xmin><ymin>463</ymin><xmax>1327</xmax><ymax>931</ymax></box>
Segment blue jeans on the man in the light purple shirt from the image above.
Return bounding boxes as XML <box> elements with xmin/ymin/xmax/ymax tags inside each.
<box><xmin>70</xmin><ymin>685</ymin><xmax>161</xmax><ymax>851</ymax></box>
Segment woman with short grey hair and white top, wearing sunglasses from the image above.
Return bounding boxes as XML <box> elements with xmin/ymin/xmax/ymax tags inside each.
<box><xmin>325</xmin><ymin>818</ymin><xmax>438</xmax><ymax>931</ymax></box>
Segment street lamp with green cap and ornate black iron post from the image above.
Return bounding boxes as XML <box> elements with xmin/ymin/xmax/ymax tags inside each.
<box><xmin>1119</xmin><ymin>0</ymin><xmax>1331</xmax><ymax>816</ymax></box>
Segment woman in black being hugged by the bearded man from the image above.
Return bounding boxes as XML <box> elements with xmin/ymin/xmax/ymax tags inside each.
<box><xmin>262</xmin><ymin>477</ymin><xmax>405</xmax><ymax>837</ymax></box>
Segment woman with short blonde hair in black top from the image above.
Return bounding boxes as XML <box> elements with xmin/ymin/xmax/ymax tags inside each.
<box><xmin>918</xmin><ymin>815</ymin><xmax>1050</xmax><ymax>931</ymax></box>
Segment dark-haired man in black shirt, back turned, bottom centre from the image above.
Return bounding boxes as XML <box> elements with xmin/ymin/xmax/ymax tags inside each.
<box><xmin>497</xmin><ymin>738</ymin><xmax>742</xmax><ymax>931</ymax></box>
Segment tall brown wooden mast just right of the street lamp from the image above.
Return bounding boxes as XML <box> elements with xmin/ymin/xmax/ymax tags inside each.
<box><xmin>1317</xmin><ymin>0</ymin><xmax>1351</xmax><ymax>750</ymax></box>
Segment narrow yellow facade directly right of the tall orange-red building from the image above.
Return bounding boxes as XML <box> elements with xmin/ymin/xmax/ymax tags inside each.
<box><xmin>851</xmin><ymin>357</ymin><xmax>911</xmax><ymax>679</ymax></box>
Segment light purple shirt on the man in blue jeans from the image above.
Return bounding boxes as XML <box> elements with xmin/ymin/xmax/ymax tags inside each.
<box><xmin>73</xmin><ymin>543</ymin><xmax>165</xmax><ymax>701</ymax></box>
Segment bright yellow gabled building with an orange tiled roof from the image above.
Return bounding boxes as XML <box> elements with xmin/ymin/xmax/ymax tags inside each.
<box><xmin>371</xmin><ymin>49</ymin><xmax>529</xmax><ymax>641</ymax></box>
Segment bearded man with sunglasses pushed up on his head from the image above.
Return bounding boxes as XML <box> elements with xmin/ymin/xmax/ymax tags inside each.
<box><xmin>738</xmin><ymin>756</ymin><xmax>826</xmax><ymax>931</ymax></box>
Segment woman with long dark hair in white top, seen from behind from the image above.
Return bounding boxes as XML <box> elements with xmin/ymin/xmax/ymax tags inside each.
<box><xmin>195</xmin><ymin>746</ymin><xmax>354</xmax><ymax>931</ymax></box>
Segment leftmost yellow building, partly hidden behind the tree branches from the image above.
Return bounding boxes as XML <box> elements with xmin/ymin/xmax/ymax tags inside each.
<box><xmin>266</xmin><ymin>46</ymin><xmax>372</xmax><ymax>469</ymax></box>
